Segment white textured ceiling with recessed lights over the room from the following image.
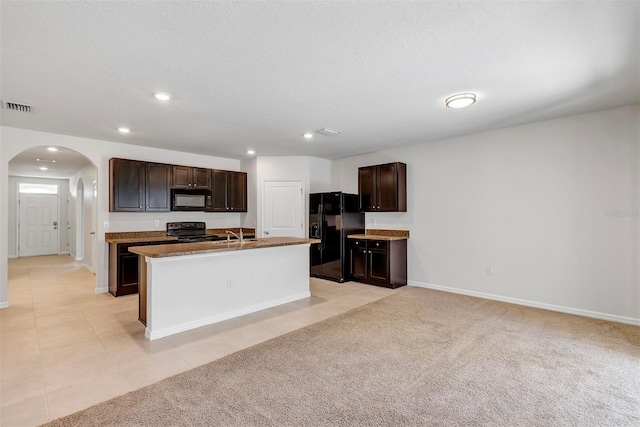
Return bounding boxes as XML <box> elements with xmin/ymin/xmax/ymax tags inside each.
<box><xmin>0</xmin><ymin>0</ymin><xmax>640</xmax><ymax>175</ymax></box>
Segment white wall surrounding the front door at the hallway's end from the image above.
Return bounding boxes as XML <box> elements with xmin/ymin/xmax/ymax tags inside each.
<box><xmin>6</xmin><ymin>176</ymin><xmax>69</xmax><ymax>258</ymax></box>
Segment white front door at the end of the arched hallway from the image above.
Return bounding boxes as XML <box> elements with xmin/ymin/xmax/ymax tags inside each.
<box><xmin>18</xmin><ymin>193</ymin><xmax>58</xmax><ymax>257</ymax></box>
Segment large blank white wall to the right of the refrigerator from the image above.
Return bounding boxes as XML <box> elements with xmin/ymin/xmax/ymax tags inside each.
<box><xmin>332</xmin><ymin>105</ymin><xmax>640</xmax><ymax>324</ymax></box>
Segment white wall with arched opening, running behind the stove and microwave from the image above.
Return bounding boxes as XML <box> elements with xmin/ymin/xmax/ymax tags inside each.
<box><xmin>0</xmin><ymin>126</ymin><xmax>250</xmax><ymax>308</ymax></box>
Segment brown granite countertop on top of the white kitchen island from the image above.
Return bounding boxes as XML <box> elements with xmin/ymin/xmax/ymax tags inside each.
<box><xmin>129</xmin><ymin>237</ymin><xmax>320</xmax><ymax>258</ymax></box>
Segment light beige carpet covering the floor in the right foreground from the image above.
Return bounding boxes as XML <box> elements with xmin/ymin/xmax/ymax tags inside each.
<box><xmin>42</xmin><ymin>288</ymin><xmax>640</xmax><ymax>426</ymax></box>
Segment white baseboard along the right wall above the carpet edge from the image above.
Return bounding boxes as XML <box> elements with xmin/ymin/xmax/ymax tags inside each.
<box><xmin>408</xmin><ymin>281</ymin><xmax>640</xmax><ymax>326</ymax></box>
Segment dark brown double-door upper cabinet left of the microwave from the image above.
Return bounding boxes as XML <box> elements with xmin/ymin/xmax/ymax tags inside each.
<box><xmin>109</xmin><ymin>158</ymin><xmax>171</xmax><ymax>212</ymax></box>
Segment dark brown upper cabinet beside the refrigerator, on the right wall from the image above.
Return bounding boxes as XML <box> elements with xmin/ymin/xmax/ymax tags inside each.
<box><xmin>358</xmin><ymin>162</ymin><xmax>407</xmax><ymax>212</ymax></box>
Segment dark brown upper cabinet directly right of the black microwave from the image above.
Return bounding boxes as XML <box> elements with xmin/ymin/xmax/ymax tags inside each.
<box><xmin>210</xmin><ymin>170</ymin><xmax>247</xmax><ymax>212</ymax></box>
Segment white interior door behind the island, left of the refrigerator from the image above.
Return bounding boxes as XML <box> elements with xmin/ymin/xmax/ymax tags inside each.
<box><xmin>262</xmin><ymin>181</ymin><xmax>305</xmax><ymax>237</ymax></box>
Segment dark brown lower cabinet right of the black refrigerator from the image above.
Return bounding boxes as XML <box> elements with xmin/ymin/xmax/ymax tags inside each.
<box><xmin>349</xmin><ymin>239</ymin><xmax>407</xmax><ymax>288</ymax></box>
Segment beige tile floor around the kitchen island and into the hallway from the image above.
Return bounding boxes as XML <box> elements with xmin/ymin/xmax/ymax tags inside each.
<box><xmin>0</xmin><ymin>255</ymin><xmax>402</xmax><ymax>427</ymax></box>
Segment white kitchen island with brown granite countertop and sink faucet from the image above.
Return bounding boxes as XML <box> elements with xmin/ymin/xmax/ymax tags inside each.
<box><xmin>129</xmin><ymin>237</ymin><xmax>317</xmax><ymax>340</ymax></box>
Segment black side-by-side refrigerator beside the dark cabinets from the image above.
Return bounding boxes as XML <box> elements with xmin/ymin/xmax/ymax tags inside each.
<box><xmin>309</xmin><ymin>191</ymin><xmax>365</xmax><ymax>283</ymax></box>
